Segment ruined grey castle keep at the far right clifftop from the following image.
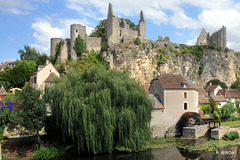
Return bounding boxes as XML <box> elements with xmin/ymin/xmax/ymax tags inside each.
<box><xmin>197</xmin><ymin>26</ymin><xmax>227</xmax><ymax>49</ymax></box>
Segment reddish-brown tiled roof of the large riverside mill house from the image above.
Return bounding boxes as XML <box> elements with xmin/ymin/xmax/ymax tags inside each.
<box><xmin>155</xmin><ymin>74</ymin><xmax>197</xmax><ymax>90</ymax></box>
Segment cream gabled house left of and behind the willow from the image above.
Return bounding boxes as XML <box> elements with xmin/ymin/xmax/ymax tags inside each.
<box><xmin>30</xmin><ymin>61</ymin><xmax>60</xmax><ymax>90</ymax></box>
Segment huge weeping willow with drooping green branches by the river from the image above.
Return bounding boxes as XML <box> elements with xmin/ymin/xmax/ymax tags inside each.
<box><xmin>46</xmin><ymin>67</ymin><xmax>152</xmax><ymax>154</ymax></box>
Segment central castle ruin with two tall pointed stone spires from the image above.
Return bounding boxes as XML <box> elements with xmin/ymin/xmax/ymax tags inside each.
<box><xmin>105</xmin><ymin>3</ymin><xmax>146</xmax><ymax>46</ymax></box>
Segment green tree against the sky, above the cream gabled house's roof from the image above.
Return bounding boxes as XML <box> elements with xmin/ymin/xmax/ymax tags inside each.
<box><xmin>18</xmin><ymin>45</ymin><xmax>48</xmax><ymax>65</ymax></box>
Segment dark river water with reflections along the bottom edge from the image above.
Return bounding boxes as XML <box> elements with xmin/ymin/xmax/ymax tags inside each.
<box><xmin>54</xmin><ymin>146</ymin><xmax>240</xmax><ymax>160</ymax></box>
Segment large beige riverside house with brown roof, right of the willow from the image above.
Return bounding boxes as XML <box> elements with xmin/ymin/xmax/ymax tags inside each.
<box><xmin>149</xmin><ymin>74</ymin><xmax>198</xmax><ymax>137</ymax></box>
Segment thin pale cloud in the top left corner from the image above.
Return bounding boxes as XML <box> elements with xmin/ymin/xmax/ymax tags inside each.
<box><xmin>0</xmin><ymin>0</ymin><xmax>36</xmax><ymax>15</ymax></box>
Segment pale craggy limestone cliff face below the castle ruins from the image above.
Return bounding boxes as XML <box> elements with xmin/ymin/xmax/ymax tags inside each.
<box><xmin>107</xmin><ymin>42</ymin><xmax>240</xmax><ymax>87</ymax></box>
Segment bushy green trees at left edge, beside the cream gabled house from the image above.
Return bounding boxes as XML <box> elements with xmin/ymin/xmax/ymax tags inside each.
<box><xmin>1</xmin><ymin>60</ymin><xmax>37</xmax><ymax>88</ymax></box>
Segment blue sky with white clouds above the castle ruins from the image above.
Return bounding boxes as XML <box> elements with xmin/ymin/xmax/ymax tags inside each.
<box><xmin>0</xmin><ymin>0</ymin><xmax>240</xmax><ymax>62</ymax></box>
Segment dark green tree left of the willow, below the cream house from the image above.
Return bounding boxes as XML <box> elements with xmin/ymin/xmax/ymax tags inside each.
<box><xmin>18</xmin><ymin>83</ymin><xmax>46</xmax><ymax>133</ymax></box>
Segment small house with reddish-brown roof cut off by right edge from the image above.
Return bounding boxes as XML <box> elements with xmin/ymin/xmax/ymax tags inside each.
<box><xmin>217</xmin><ymin>89</ymin><xmax>240</xmax><ymax>107</ymax></box>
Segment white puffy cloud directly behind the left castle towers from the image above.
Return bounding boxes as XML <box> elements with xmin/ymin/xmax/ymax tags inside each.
<box><xmin>30</xmin><ymin>17</ymin><xmax>93</xmax><ymax>55</ymax></box>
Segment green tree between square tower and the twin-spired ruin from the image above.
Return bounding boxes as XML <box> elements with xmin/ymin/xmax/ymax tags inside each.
<box><xmin>90</xmin><ymin>19</ymin><xmax>107</xmax><ymax>39</ymax></box>
